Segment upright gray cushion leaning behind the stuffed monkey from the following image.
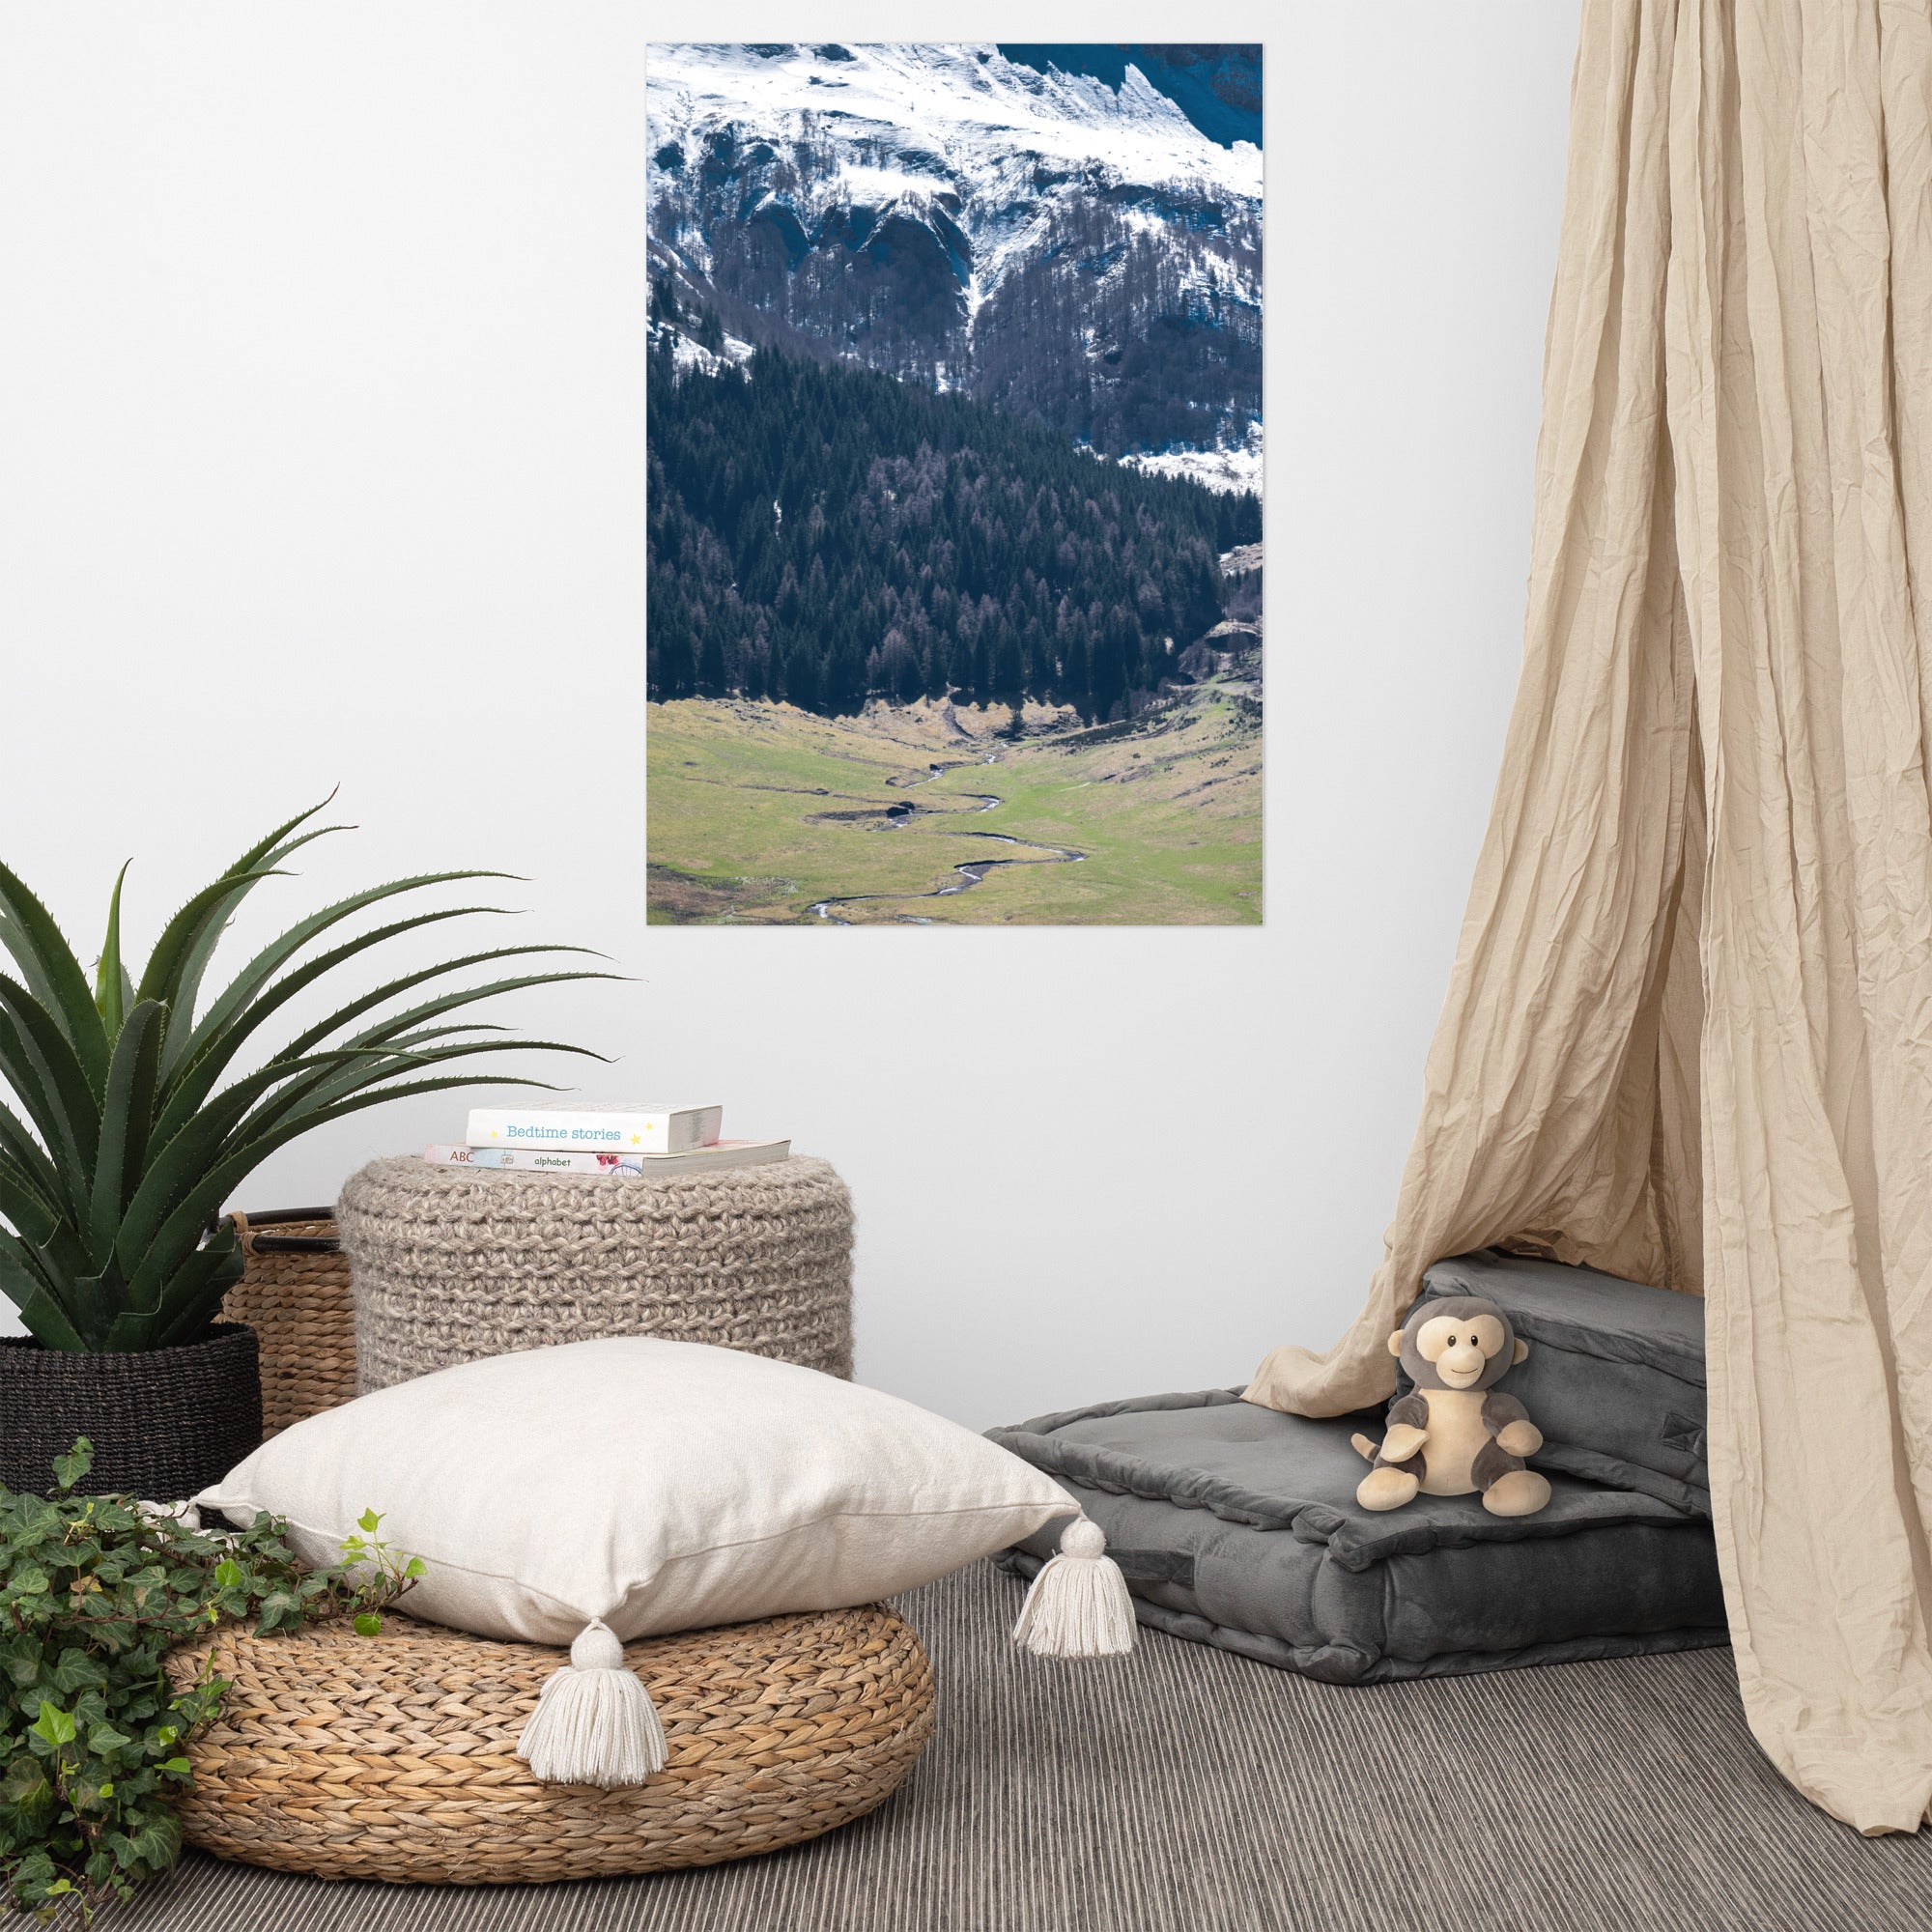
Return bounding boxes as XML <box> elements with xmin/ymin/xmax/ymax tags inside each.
<box><xmin>1422</xmin><ymin>1248</ymin><xmax>1710</xmax><ymax>1517</ymax></box>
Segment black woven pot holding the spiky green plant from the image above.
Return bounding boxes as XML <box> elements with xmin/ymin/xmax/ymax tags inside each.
<box><xmin>0</xmin><ymin>1321</ymin><xmax>261</xmax><ymax>1503</ymax></box>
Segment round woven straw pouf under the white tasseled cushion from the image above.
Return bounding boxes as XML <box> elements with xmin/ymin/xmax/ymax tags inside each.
<box><xmin>168</xmin><ymin>1604</ymin><xmax>933</xmax><ymax>1886</ymax></box>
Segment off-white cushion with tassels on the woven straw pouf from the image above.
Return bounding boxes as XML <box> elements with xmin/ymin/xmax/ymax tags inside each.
<box><xmin>195</xmin><ymin>1337</ymin><xmax>1132</xmax><ymax>1785</ymax></box>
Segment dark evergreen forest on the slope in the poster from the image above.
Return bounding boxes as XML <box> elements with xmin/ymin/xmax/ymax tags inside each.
<box><xmin>647</xmin><ymin>327</ymin><xmax>1262</xmax><ymax>717</ymax></box>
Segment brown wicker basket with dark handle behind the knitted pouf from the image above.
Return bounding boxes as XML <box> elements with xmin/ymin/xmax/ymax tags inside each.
<box><xmin>222</xmin><ymin>1208</ymin><xmax>355</xmax><ymax>1439</ymax></box>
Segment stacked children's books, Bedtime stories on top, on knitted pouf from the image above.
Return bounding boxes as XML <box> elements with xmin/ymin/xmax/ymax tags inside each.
<box><xmin>423</xmin><ymin>1107</ymin><xmax>792</xmax><ymax>1175</ymax></box>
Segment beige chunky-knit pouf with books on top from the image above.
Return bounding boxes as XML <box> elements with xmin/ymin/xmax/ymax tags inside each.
<box><xmin>336</xmin><ymin>1157</ymin><xmax>852</xmax><ymax>1393</ymax></box>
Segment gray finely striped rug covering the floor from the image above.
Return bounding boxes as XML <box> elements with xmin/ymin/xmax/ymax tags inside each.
<box><xmin>128</xmin><ymin>1567</ymin><xmax>1932</xmax><ymax>1932</ymax></box>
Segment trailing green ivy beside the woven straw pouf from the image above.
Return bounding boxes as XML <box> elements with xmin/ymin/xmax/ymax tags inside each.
<box><xmin>0</xmin><ymin>1437</ymin><xmax>423</xmax><ymax>1926</ymax></box>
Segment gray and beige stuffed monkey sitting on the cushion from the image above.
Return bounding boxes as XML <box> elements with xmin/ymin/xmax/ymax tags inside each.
<box><xmin>1354</xmin><ymin>1294</ymin><xmax>1549</xmax><ymax>1517</ymax></box>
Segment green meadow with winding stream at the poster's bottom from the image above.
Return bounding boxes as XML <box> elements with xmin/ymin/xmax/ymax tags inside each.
<box><xmin>647</xmin><ymin>682</ymin><xmax>1262</xmax><ymax>925</ymax></box>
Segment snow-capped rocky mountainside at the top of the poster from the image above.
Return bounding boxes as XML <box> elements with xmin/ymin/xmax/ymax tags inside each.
<box><xmin>647</xmin><ymin>43</ymin><xmax>1262</xmax><ymax>489</ymax></box>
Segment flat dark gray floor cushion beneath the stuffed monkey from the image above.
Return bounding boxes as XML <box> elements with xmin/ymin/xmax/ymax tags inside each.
<box><xmin>991</xmin><ymin>1389</ymin><xmax>1727</xmax><ymax>1683</ymax></box>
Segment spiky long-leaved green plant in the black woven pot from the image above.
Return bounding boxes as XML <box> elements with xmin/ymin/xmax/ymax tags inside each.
<box><xmin>0</xmin><ymin>800</ymin><xmax>616</xmax><ymax>1352</ymax></box>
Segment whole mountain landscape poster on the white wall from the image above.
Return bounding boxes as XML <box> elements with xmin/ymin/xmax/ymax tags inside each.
<box><xmin>645</xmin><ymin>43</ymin><xmax>1264</xmax><ymax>925</ymax></box>
